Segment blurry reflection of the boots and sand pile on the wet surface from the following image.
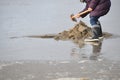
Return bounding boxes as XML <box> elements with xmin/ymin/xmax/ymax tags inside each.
<box><xmin>71</xmin><ymin>41</ymin><xmax>102</xmax><ymax>60</ymax></box>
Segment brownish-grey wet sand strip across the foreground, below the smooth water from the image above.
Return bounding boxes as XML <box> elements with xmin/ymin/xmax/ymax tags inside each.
<box><xmin>0</xmin><ymin>58</ymin><xmax>120</xmax><ymax>80</ymax></box>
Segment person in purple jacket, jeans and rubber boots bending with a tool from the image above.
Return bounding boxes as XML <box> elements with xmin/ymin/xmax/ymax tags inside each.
<box><xmin>72</xmin><ymin>0</ymin><xmax>111</xmax><ymax>41</ymax></box>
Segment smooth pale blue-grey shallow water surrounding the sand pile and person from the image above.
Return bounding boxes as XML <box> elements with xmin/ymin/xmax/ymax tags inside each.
<box><xmin>0</xmin><ymin>0</ymin><xmax>120</xmax><ymax>60</ymax></box>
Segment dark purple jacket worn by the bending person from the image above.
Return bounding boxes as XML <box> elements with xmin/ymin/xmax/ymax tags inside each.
<box><xmin>81</xmin><ymin>0</ymin><xmax>111</xmax><ymax>17</ymax></box>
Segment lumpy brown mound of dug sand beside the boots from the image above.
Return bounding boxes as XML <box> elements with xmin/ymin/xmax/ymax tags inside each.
<box><xmin>54</xmin><ymin>21</ymin><xmax>91</xmax><ymax>40</ymax></box>
